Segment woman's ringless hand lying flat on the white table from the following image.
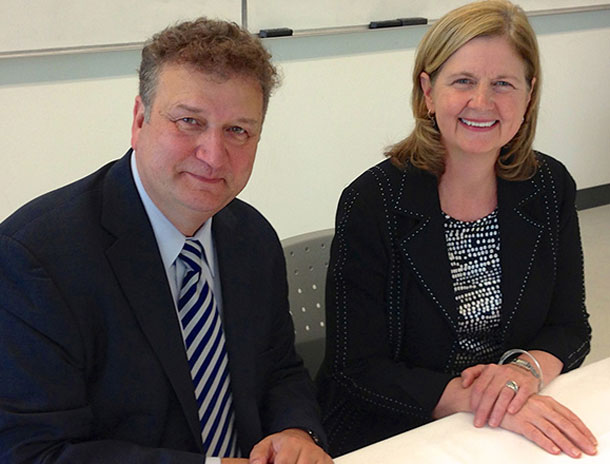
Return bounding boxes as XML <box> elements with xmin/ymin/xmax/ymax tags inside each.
<box><xmin>500</xmin><ymin>395</ymin><xmax>597</xmax><ymax>458</ymax></box>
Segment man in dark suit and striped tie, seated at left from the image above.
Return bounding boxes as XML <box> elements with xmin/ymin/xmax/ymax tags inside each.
<box><xmin>0</xmin><ymin>19</ymin><xmax>331</xmax><ymax>464</ymax></box>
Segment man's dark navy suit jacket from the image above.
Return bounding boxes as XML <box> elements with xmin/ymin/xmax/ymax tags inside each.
<box><xmin>0</xmin><ymin>152</ymin><xmax>323</xmax><ymax>464</ymax></box>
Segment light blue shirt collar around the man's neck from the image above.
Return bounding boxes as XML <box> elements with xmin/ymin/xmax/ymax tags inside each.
<box><xmin>131</xmin><ymin>150</ymin><xmax>216</xmax><ymax>277</ymax></box>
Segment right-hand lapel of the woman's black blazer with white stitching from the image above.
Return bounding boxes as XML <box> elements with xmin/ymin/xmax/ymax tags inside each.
<box><xmin>498</xmin><ymin>179</ymin><xmax>545</xmax><ymax>336</ymax></box>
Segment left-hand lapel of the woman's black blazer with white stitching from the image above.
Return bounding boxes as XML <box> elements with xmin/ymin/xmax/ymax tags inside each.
<box><xmin>394</xmin><ymin>166</ymin><xmax>457</xmax><ymax>330</ymax></box>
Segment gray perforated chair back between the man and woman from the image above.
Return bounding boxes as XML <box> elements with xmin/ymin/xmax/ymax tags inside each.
<box><xmin>282</xmin><ymin>229</ymin><xmax>335</xmax><ymax>379</ymax></box>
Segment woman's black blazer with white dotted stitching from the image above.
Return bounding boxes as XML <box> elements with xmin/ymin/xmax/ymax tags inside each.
<box><xmin>318</xmin><ymin>154</ymin><xmax>590</xmax><ymax>455</ymax></box>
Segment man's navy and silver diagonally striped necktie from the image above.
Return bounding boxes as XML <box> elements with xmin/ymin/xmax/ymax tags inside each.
<box><xmin>178</xmin><ymin>239</ymin><xmax>237</xmax><ymax>457</ymax></box>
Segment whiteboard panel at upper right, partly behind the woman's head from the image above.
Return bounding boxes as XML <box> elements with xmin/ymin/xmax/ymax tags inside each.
<box><xmin>248</xmin><ymin>0</ymin><xmax>610</xmax><ymax>32</ymax></box>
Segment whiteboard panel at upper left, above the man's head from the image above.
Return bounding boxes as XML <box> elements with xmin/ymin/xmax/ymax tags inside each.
<box><xmin>0</xmin><ymin>0</ymin><xmax>241</xmax><ymax>53</ymax></box>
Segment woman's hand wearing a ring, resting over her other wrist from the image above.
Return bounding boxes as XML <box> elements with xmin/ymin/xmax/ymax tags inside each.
<box><xmin>461</xmin><ymin>364</ymin><xmax>539</xmax><ymax>427</ymax></box>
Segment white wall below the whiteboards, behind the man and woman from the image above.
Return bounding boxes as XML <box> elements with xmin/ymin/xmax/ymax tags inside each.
<box><xmin>0</xmin><ymin>10</ymin><xmax>610</xmax><ymax>238</ymax></box>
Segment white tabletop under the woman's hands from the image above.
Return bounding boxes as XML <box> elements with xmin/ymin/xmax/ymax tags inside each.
<box><xmin>335</xmin><ymin>358</ymin><xmax>610</xmax><ymax>464</ymax></box>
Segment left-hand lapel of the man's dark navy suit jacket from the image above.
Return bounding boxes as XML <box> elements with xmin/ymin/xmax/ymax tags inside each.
<box><xmin>101</xmin><ymin>150</ymin><xmax>202</xmax><ymax>448</ymax></box>
